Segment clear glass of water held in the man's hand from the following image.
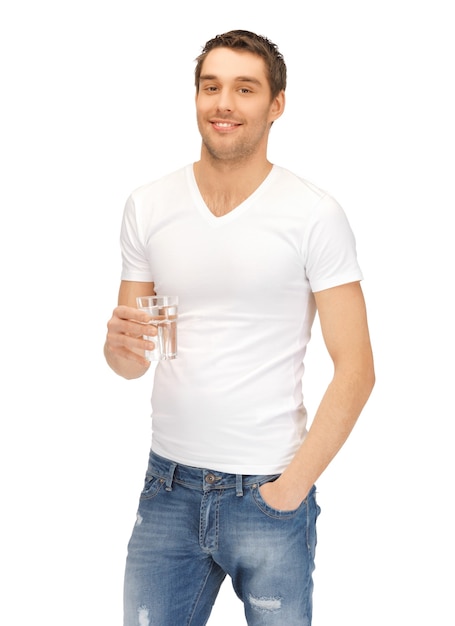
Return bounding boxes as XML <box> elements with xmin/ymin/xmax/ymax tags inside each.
<box><xmin>136</xmin><ymin>296</ymin><xmax>178</xmax><ymax>361</ymax></box>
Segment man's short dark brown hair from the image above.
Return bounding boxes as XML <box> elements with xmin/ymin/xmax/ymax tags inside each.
<box><xmin>194</xmin><ymin>30</ymin><xmax>286</xmax><ymax>98</ymax></box>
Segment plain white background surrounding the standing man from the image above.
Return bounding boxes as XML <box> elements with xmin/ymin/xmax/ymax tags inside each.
<box><xmin>0</xmin><ymin>0</ymin><xmax>455</xmax><ymax>626</ymax></box>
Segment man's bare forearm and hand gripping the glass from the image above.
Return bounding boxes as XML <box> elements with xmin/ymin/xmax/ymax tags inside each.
<box><xmin>104</xmin><ymin>281</ymin><xmax>156</xmax><ymax>379</ymax></box>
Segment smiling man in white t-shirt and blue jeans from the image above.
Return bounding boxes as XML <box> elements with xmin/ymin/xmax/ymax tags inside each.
<box><xmin>105</xmin><ymin>31</ymin><xmax>374</xmax><ymax>626</ymax></box>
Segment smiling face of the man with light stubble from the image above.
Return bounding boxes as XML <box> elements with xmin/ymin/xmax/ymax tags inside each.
<box><xmin>196</xmin><ymin>48</ymin><xmax>284</xmax><ymax>162</ymax></box>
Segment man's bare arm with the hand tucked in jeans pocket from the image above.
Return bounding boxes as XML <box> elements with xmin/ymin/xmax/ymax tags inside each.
<box><xmin>261</xmin><ymin>283</ymin><xmax>375</xmax><ymax>510</ymax></box>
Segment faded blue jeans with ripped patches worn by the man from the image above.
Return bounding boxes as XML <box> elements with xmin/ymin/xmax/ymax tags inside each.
<box><xmin>124</xmin><ymin>452</ymin><xmax>320</xmax><ymax>626</ymax></box>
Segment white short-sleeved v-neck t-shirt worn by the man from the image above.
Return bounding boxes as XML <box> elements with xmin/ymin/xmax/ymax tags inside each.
<box><xmin>121</xmin><ymin>165</ymin><xmax>362</xmax><ymax>474</ymax></box>
